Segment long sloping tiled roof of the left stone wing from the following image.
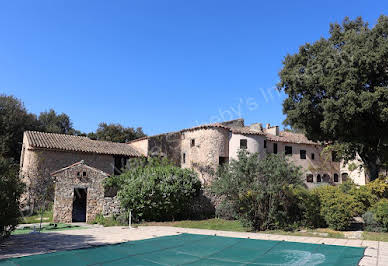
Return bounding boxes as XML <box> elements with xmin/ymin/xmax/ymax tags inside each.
<box><xmin>25</xmin><ymin>131</ymin><xmax>142</xmax><ymax>157</ymax></box>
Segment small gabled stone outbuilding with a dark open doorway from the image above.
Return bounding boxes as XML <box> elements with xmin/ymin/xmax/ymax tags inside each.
<box><xmin>51</xmin><ymin>161</ymin><xmax>109</xmax><ymax>223</ymax></box>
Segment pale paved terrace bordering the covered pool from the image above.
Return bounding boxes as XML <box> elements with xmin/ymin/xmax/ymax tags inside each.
<box><xmin>0</xmin><ymin>226</ymin><xmax>388</xmax><ymax>266</ymax></box>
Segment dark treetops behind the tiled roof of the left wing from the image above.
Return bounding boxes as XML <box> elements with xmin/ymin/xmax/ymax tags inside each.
<box><xmin>0</xmin><ymin>94</ymin><xmax>145</xmax><ymax>162</ymax></box>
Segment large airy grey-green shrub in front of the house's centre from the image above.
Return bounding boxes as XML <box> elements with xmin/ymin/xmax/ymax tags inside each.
<box><xmin>211</xmin><ymin>150</ymin><xmax>302</xmax><ymax>230</ymax></box>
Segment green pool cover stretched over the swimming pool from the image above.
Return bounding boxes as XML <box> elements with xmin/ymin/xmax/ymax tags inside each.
<box><xmin>0</xmin><ymin>234</ymin><xmax>365</xmax><ymax>266</ymax></box>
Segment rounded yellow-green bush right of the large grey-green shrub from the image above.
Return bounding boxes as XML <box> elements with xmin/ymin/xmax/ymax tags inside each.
<box><xmin>316</xmin><ymin>185</ymin><xmax>359</xmax><ymax>230</ymax></box>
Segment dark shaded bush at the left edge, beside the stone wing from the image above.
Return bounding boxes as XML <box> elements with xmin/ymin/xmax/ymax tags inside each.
<box><xmin>0</xmin><ymin>157</ymin><xmax>24</xmax><ymax>239</ymax></box>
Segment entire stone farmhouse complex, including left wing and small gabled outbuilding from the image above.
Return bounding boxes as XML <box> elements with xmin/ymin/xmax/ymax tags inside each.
<box><xmin>20</xmin><ymin>119</ymin><xmax>366</xmax><ymax>222</ymax></box>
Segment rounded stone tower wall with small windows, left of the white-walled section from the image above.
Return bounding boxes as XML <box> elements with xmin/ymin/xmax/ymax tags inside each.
<box><xmin>181</xmin><ymin>128</ymin><xmax>229</xmax><ymax>185</ymax></box>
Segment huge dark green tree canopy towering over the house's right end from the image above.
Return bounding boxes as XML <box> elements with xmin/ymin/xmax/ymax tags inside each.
<box><xmin>278</xmin><ymin>16</ymin><xmax>388</xmax><ymax>180</ymax></box>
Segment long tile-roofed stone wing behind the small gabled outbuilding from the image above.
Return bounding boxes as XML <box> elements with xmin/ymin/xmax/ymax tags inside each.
<box><xmin>20</xmin><ymin>131</ymin><xmax>142</xmax><ymax>209</ymax></box>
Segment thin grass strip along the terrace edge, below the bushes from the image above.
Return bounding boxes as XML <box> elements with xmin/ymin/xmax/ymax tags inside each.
<box><xmin>139</xmin><ymin>218</ymin><xmax>388</xmax><ymax>242</ymax></box>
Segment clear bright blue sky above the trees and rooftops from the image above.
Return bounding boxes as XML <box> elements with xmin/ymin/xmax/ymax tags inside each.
<box><xmin>0</xmin><ymin>0</ymin><xmax>388</xmax><ymax>134</ymax></box>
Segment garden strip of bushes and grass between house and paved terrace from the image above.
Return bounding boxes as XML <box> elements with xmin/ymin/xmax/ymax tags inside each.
<box><xmin>100</xmin><ymin>151</ymin><xmax>388</xmax><ymax>241</ymax></box>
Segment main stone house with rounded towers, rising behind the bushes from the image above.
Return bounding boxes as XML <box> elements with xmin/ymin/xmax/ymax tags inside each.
<box><xmin>129</xmin><ymin>119</ymin><xmax>365</xmax><ymax>188</ymax></box>
